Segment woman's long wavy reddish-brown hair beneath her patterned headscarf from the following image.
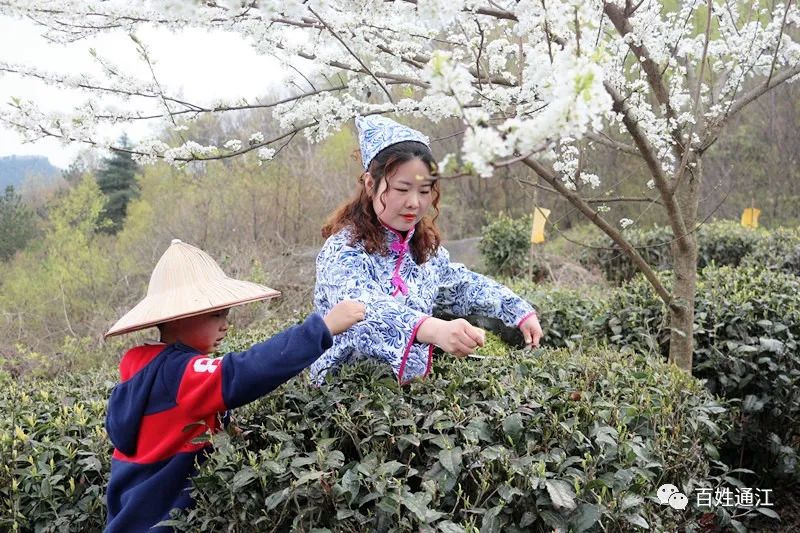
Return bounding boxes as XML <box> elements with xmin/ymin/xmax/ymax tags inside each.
<box><xmin>322</xmin><ymin>137</ymin><xmax>441</xmax><ymax>265</ymax></box>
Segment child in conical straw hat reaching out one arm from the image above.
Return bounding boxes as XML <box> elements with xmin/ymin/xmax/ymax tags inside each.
<box><xmin>106</xmin><ymin>239</ymin><xmax>364</xmax><ymax>532</ymax></box>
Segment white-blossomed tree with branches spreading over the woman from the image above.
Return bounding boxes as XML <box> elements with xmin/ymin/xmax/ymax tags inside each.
<box><xmin>0</xmin><ymin>0</ymin><xmax>800</xmax><ymax>371</ymax></box>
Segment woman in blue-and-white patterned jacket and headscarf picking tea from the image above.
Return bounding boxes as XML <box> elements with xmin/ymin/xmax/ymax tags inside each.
<box><xmin>311</xmin><ymin>116</ymin><xmax>542</xmax><ymax>384</ymax></box>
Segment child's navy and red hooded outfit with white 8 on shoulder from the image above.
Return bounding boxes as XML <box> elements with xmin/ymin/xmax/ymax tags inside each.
<box><xmin>106</xmin><ymin>314</ymin><xmax>333</xmax><ymax>533</ymax></box>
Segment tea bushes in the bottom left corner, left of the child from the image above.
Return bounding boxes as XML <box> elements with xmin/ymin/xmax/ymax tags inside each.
<box><xmin>0</xmin><ymin>371</ymin><xmax>113</xmax><ymax>532</ymax></box>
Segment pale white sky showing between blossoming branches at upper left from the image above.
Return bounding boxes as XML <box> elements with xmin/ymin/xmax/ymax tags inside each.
<box><xmin>0</xmin><ymin>16</ymin><xmax>281</xmax><ymax>168</ymax></box>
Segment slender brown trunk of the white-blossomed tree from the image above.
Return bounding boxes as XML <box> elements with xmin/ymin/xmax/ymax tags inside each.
<box><xmin>669</xmin><ymin>157</ymin><xmax>702</xmax><ymax>373</ymax></box>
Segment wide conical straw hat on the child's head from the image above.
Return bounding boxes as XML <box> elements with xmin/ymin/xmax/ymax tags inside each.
<box><xmin>105</xmin><ymin>239</ymin><xmax>280</xmax><ymax>337</ymax></box>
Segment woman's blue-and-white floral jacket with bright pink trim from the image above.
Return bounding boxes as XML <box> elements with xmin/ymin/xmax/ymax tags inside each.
<box><xmin>310</xmin><ymin>223</ymin><xmax>534</xmax><ymax>384</ymax></box>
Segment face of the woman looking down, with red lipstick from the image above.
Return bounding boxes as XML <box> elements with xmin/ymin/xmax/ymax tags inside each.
<box><xmin>364</xmin><ymin>158</ymin><xmax>433</xmax><ymax>231</ymax></box>
